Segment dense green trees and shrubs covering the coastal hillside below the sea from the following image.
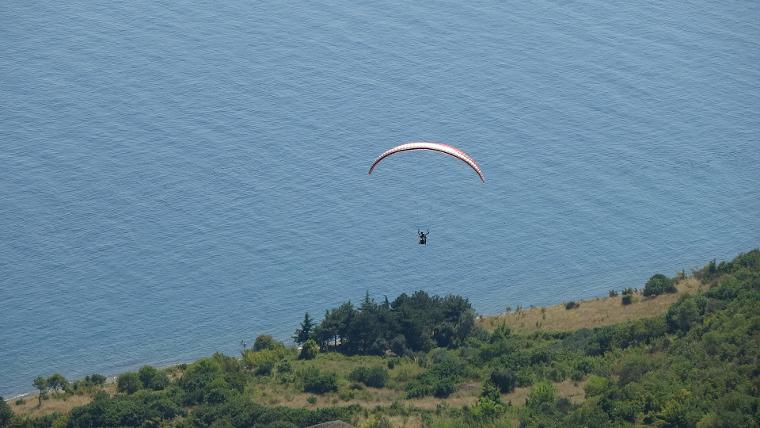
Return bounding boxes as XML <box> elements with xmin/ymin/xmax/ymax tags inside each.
<box><xmin>0</xmin><ymin>250</ymin><xmax>760</xmax><ymax>427</ymax></box>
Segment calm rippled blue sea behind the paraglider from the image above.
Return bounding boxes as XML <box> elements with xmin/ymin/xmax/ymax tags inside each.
<box><xmin>0</xmin><ymin>0</ymin><xmax>760</xmax><ymax>396</ymax></box>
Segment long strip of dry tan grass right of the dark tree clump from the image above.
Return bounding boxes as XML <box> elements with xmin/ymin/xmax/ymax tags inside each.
<box><xmin>480</xmin><ymin>278</ymin><xmax>702</xmax><ymax>333</ymax></box>
